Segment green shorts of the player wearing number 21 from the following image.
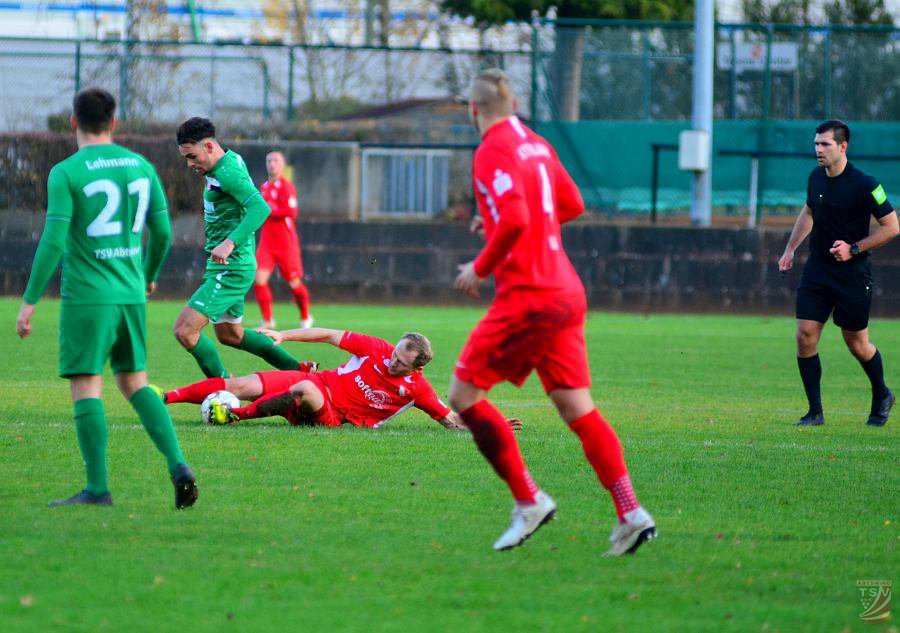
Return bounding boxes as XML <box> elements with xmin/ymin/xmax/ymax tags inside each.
<box><xmin>59</xmin><ymin>303</ymin><xmax>147</xmax><ymax>378</ymax></box>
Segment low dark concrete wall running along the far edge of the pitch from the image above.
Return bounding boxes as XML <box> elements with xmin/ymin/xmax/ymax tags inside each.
<box><xmin>0</xmin><ymin>213</ymin><xmax>900</xmax><ymax>317</ymax></box>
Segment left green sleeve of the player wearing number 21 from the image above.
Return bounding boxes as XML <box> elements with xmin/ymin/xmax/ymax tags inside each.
<box><xmin>23</xmin><ymin>168</ymin><xmax>72</xmax><ymax>304</ymax></box>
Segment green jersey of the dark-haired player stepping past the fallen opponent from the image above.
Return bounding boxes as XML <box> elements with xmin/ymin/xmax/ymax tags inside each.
<box><xmin>203</xmin><ymin>150</ymin><xmax>270</xmax><ymax>270</ymax></box>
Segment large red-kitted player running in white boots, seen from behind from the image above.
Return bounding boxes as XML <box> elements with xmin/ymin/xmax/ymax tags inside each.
<box><xmin>450</xmin><ymin>69</ymin><xmax>656</xmax><ymax>556</ymax></box>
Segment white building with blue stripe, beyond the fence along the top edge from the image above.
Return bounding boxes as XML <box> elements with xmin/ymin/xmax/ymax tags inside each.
<box><xmin>0</xmin><ymin>0</ymin><xmax>900</xmax><ymax>49</ymax></box>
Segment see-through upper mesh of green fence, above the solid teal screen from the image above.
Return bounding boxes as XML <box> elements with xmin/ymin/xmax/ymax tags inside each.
<box><xmin>530</xmin><ymin>20</ymin><xmax>900</xmax><ymax>121</ymax></box>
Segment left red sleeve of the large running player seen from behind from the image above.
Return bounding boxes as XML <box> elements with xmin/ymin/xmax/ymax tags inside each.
<box><xmin>473</xmin><ymin>149</ymin><xmax>528</xmax><ymax>277</ymax></box>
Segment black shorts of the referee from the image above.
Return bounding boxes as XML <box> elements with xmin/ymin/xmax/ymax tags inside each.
<box><xmin>797</xmin><ymin>255</ymin><xmax>874</xmax><ymax>332</ymax></box>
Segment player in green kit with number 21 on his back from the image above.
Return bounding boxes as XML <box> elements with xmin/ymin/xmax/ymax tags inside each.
<box><xmin>16</xmin><ymin>88</ymin><xmax>197</xmax><ymax>508</ymax></box>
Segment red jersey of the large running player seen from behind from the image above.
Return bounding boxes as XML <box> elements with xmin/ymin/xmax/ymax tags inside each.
<box><xmin>472</xmin><ymin>116</ymin><xmax>584</xmax><ymax>297</ymax></box>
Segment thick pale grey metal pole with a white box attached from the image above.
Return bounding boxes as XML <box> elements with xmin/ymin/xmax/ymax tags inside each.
<box><xmin>691</xmin><ymin>0</ymin><xmax>715</xmax><ymax>226</ymax></box>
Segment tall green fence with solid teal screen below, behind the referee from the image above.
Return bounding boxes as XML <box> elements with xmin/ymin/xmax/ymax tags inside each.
<box><xmin>531</xmin><ymin>20</ymin><xmax>900</xmax><ymax>223</ymax></box>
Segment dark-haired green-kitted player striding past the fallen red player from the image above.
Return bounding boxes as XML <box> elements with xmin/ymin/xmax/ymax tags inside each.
<box><xmin>175</xmin><ymin>117</ymin><xmax>300</xmax><ymax>378</ymax></box>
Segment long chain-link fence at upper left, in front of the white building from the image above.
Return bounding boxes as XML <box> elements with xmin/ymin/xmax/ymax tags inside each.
<box><xmin>0</xmin><ymin>38</ymin><xmax>530</xmax><ymax>132</ymax></box>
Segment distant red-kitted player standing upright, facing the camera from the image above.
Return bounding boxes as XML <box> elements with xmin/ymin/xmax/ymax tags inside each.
<box><xmin>253</xmin><ymin>151</ymin><xmax>313</xmax><ymax>328</ymax></box>
